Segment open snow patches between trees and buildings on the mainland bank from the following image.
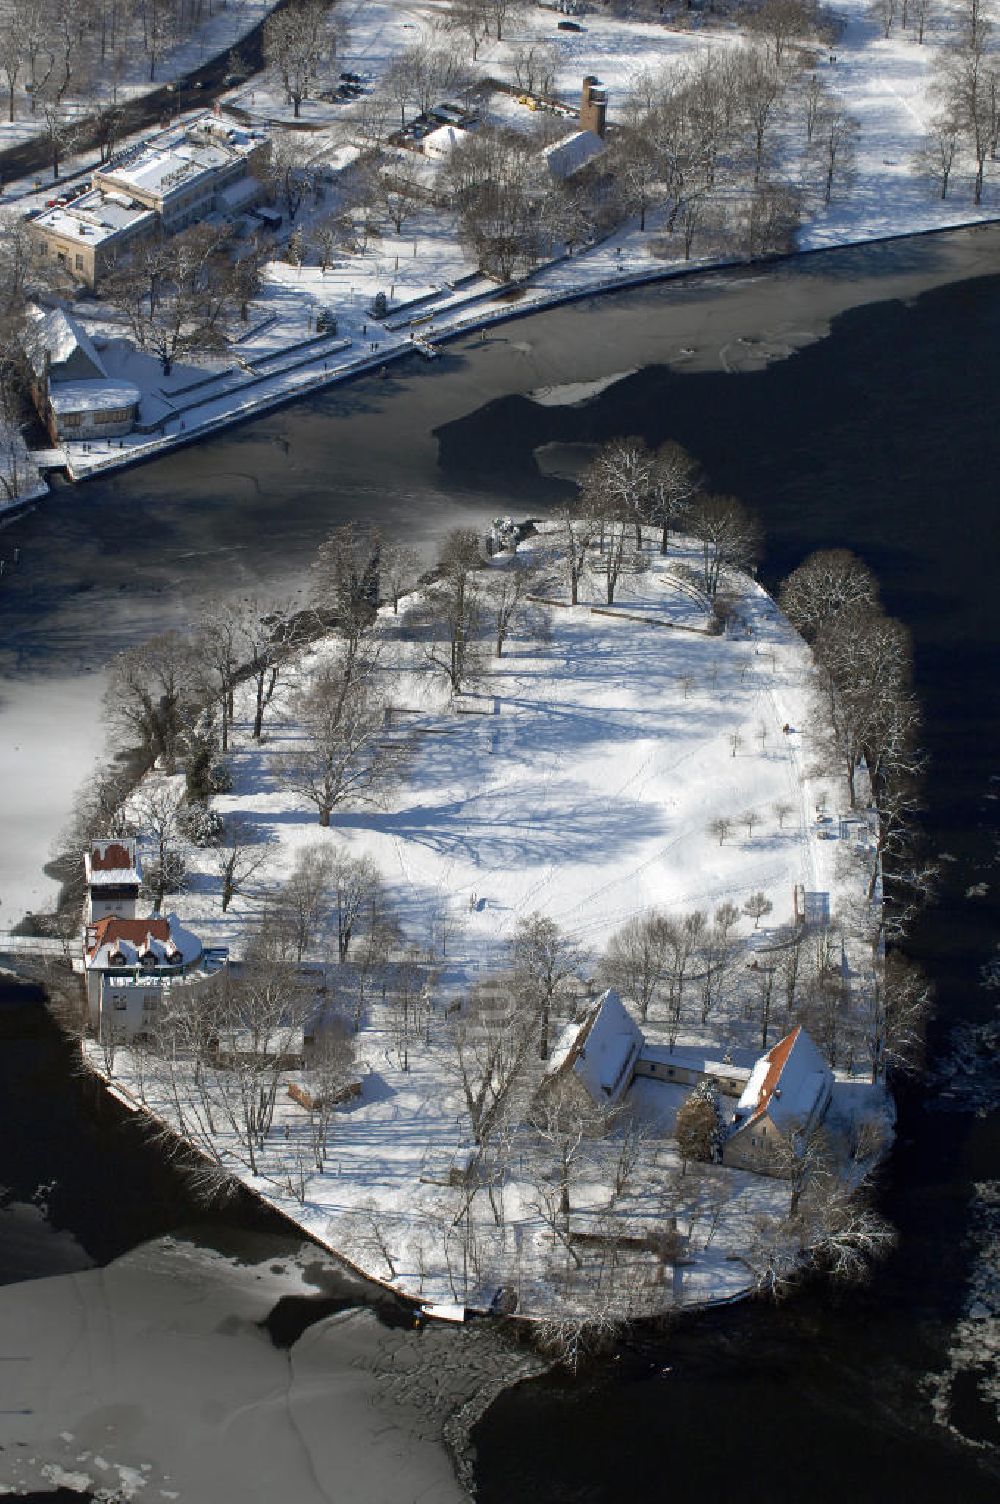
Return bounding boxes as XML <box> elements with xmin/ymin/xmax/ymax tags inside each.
<box><xmin>7</xmin><ymin>0</ymin><xmax>1000</xmax><ymax>493</ymax></box>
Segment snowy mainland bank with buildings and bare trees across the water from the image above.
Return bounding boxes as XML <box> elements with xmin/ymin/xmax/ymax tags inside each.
<box><xmin>0</xmin><ymin>0</ymin><xmax>997</xmax><ymax>511</ymax></box>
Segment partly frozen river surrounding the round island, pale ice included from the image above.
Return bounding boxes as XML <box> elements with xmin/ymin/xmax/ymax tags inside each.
<box><xmin>0</xmin><ymin>229</ymin><xmax>1000</xmax><ymax>1504</ymax></box>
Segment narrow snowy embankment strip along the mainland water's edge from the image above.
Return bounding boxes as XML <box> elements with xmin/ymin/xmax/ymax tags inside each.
<box><xmin>15</xmin><ymin>215</ymin><xmax>1000</xmax><ymax>499</ymax></box>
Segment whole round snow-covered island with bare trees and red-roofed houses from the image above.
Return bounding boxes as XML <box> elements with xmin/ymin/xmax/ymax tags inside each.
<box><xmin>62</xmin><ymin>513</ymin><xmax>892</xmax><ymax>1348</ymax></box>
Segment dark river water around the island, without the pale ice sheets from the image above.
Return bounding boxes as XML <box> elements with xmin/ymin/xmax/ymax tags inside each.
<box><xmin>0</xmin><ymin>232</ymin><xmax>1000</xmax><ymax>1504</ymax></box>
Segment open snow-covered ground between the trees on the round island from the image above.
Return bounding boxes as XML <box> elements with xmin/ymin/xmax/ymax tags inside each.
<box><xmin>84</xmin><ymin>531</ymin><xmax>883</xmax><ymax>1313</ymax></box>
